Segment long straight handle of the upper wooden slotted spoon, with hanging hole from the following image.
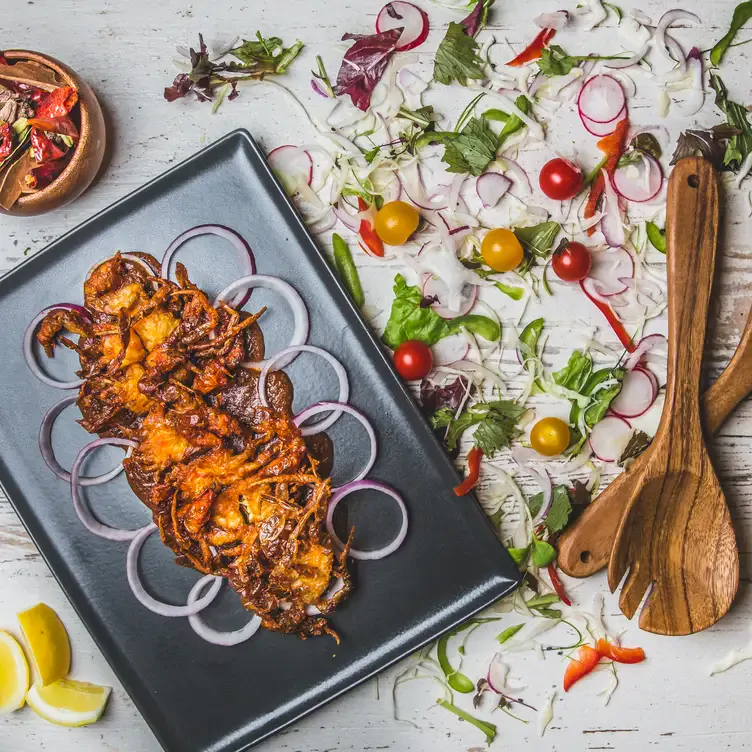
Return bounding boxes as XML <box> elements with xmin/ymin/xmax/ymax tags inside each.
<box><xmin>654</xmin><ymin>157</ymin><xmax>719</xmax><ymax>472</ymax></box>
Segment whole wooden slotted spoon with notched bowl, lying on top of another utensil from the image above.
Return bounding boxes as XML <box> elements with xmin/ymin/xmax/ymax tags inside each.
<box><xmin>608</xmin><ymin>157</ymin><xmax>739</xmax><ymax>635</ymax></box>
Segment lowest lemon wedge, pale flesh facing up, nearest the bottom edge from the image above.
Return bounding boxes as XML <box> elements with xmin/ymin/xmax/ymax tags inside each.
<box><xmin>26</xmin><ymin>679</ymin><xmax>112</xmax><ymax>727</ymax></box>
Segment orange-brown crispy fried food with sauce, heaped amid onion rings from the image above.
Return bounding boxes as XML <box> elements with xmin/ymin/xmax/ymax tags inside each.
<box><xmin>37</xmin><ymin>254</ymin><xmax>352</xmax><ymax>639</ymax></box>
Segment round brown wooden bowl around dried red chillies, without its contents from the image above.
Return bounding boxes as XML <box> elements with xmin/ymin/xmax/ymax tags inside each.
<box><xmin>0</xmin><ymin>50</ymin><xmax>106</xmax><ymax>216</ymax></box>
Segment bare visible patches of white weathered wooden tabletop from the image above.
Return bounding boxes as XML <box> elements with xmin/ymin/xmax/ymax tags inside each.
<box><xmin>0</xmin><ymin>0</ymin><xmax>752</xmax><ymax>752</ymax></box>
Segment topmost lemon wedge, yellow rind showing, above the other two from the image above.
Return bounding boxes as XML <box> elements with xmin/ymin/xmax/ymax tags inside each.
<box><xmin>18</xmin><ymin>603</ymin><xmax>70</xmax><ymax>687</ymax></box>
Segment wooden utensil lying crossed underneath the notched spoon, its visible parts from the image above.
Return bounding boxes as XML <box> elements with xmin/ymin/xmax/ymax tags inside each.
<box><xmin>556</xmin><ymin>308</ymin><xmax>752</xmax><ymax>577</ymax></box>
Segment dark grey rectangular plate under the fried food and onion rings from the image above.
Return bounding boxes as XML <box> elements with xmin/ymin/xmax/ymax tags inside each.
<box><xmin>0</xmin><ymin>131</ymin><xmax>519</xmax><ymax>752</ymax></box>
